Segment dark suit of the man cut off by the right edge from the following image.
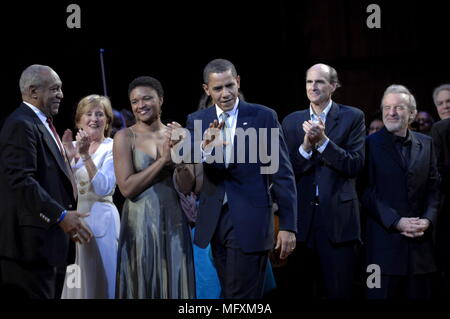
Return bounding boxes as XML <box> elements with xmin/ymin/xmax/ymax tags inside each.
<box><xmin>431</xmin><ymin>118</ymin><xmax>450</xmax><ymax>298</ymax></box>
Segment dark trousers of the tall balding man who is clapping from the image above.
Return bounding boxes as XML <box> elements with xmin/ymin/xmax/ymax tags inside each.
<box><xmin>275</xmin><ymin>205</ymin><xmax>358</xmax><ymax>299</ymax></box>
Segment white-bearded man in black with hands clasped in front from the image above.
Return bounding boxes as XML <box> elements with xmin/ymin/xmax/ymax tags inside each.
<box><xmin>362</xmin><ymin>85</ymin><xmax>439</xmax><ymax>299</ymax></box>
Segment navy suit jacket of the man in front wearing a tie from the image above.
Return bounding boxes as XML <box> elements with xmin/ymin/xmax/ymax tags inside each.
<box><xmin>186</xmin><ymin>101</ymin><xmax>297</xmax><ymax>252</ymax></box>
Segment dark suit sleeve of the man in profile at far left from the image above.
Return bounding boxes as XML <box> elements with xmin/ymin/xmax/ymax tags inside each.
<box><xmin>0</xmin><ymin>121</ymin><xmax>64</xmax><ymax>224</ymax></box>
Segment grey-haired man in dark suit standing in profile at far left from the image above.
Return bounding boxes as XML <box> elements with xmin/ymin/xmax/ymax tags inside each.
<box><xmin>0</xmin><ymin>65</ymin><xmax>91</xmax><ymax>298</ymax></box>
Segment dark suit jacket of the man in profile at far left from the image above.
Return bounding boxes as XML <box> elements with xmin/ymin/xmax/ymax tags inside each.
<box><xmin>0</xmin><ymin>104</ymin><xmax>75</xmax><ymax>266</ymax></box>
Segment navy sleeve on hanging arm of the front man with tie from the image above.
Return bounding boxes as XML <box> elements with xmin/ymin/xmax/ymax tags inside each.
<box><xmin>270</xmin><ymin>112</ymin><xmax>297</xmax><ymax>232</ymax></box>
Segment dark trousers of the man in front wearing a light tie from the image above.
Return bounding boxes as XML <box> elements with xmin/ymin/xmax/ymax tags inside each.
<box><xmin>211</xmin><ymin>205</ymin><xmax>268</xmax><ymax>299</ymax></box>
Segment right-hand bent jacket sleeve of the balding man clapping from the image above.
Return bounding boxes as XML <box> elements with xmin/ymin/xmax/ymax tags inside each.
<box><xmin>322</xmin><ymin>112</ymin><xmax>366</xmax><ymax>178</ymax></box>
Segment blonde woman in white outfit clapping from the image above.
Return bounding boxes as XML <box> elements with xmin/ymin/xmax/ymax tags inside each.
<box><xmin>62</xmin><ymin>95</ymin><xmax>120</xmax><ymax>299</ymax></box>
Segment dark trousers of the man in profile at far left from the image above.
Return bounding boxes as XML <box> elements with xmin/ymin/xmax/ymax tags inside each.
<box><xmin>0</xmin><ymin>257</ymin><xmax>65</xmax><ymax>299</ymax></box>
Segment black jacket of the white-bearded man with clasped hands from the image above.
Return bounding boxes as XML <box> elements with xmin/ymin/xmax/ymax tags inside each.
<box><xmin>362</xmin><ymin>128</ymin><xmax>439</xmax><ymax>275</ymax></box>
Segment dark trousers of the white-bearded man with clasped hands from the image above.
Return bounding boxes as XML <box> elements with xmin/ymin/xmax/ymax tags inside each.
<box><xmin>367</xmin><ymin>274</ymin><xmax>434</xmax><ymax>300</ymax></box>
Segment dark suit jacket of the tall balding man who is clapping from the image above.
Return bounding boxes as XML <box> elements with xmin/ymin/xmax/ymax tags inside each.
<box><xmin>283</xmin><ymin>102</ymin><xmax>365</xmax><ymax>243</ymax></box>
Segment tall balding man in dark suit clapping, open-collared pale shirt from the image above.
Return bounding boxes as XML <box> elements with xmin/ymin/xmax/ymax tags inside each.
<box><xmin>280</xmin><ymin>64</ymin><xmax>365</xmax><ymax>299</ymax></box>
